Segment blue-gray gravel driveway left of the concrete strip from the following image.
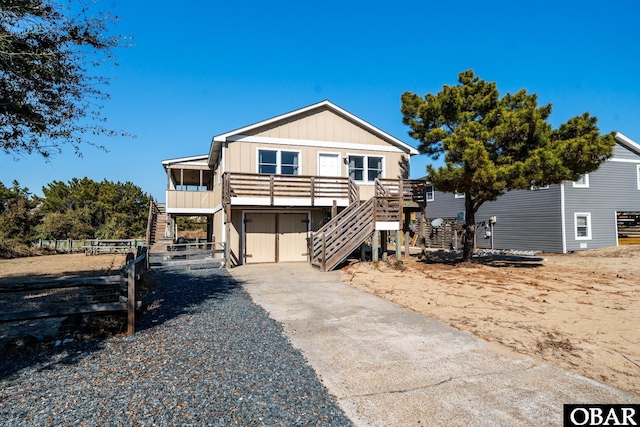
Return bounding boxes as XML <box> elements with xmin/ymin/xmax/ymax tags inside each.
<box><xmin>0</xmin><ymin>269</ymin><xmax>351</xmax><ymax>426</ymax></box>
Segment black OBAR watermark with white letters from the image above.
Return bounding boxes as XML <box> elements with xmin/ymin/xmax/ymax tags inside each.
<box><xmin>563</xmin><ymin>405</ymin><xmax>640</xmax><ymax>427</ymax></box>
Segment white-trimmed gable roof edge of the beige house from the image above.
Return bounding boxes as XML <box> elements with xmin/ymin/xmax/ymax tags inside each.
<box><xmin>209</xmin><ymin>99</ymin><xmax>418</xmax><ymax>165</ymax></box>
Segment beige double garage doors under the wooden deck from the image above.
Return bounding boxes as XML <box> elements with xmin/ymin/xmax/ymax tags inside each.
<box><xmin>245</xmin><ymin>213</ymin><xmax>308</xmax><ymax>264</ymax></box>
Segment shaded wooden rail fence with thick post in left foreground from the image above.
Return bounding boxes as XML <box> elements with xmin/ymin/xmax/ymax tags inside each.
<box><xmin>0</xmin><ymin>247</ymin><xmax>149</xmax><ymax>335</ymax></box>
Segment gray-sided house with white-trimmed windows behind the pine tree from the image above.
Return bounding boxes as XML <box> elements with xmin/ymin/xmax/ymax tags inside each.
<box><xmin>426</xmin><ymin>133</ymin><xmax>640</xmax><ymax>253</ymax></box>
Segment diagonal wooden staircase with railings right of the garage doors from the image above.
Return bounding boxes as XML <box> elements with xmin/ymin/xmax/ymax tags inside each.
<box><xmin>310</xmin><ymin>180</ymin><xmax>402</xmax><ymax>271</ymax></box>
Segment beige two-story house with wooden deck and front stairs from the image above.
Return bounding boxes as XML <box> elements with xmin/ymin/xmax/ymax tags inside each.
<box><xmin>157</xmin><ymin>101</ymin><xmax>424</xmax><ymax>269</ymax></box>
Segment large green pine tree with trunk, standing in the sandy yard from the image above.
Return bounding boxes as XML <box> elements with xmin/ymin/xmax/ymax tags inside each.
<box><xmin>401</xmin><ymin>70</ymin><xmax>614</xmax><ymax>260</ymax></box>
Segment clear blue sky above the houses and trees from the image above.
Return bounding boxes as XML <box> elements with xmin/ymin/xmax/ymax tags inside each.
<box><xmin>0</xmin><ymin>0</ymin><xmax>640</xmax><ymax>201</ymax></box>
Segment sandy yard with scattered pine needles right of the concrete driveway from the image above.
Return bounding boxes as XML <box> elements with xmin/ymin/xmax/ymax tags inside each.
<box><xmin>342</xmin><ymin>246</ymin><xmax>640</xmax><ymax>395</ymax></box>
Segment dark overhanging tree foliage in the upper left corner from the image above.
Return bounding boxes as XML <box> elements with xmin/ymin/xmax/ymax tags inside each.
<box><xmin>0</xmin><ymin>0</ymin><xmax>130</xmax><ymax>157</ymax></box>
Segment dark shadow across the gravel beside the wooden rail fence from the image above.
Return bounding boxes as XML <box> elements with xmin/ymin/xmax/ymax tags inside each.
<box><xmin>0</xmin><ymin>268</ymin><xmax>242</xmax><ymax>380</ymax></box>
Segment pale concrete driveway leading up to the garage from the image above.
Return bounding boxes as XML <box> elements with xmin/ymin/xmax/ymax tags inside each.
<box><xmin>230</xmin><ymin>264</ymin><xmax>640</xmax><ymax>426</ymax></box>
